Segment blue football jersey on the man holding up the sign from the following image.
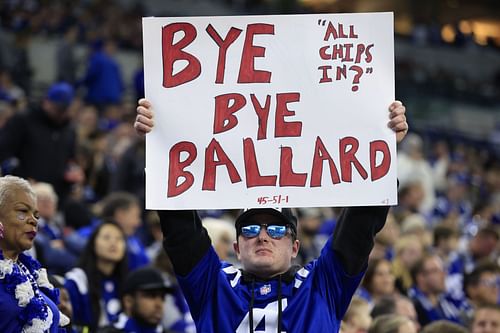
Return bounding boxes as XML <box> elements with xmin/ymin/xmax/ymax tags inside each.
<box><xmin>178</xmin><ymin>238</ymin><xmax>364</xmax><ymax>333</ymax></box>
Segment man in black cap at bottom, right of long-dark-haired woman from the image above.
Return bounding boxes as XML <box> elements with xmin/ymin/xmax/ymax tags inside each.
<box><xmin>114</xmin><ymin>267</ymin><xmax>176</xmax><ymax>333</ymax></box>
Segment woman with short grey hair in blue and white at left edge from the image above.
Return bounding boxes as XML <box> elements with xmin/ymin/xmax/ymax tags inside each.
<box><xmin>0</xmin><ymin>176</ymin><xmax>69</xmax><ymax>333</ymax></box>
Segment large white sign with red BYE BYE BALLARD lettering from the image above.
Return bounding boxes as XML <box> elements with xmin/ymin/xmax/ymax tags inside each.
<box><xmin>143</xmin><ymin>13</ymin><xmax>397</xmax><ymax>209</ymax></box>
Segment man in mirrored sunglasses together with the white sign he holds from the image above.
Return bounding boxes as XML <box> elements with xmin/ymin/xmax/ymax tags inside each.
<box><xmin>135</xmin><ymin>13</ymin><xmax>408</xmax><ymax>333</ymax></box>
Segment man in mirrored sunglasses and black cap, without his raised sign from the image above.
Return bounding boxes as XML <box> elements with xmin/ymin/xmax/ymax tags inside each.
<box><xmin>134</xmin><ymin>99</ymin><xmax>408</xmax><ymax>333</ymax></box>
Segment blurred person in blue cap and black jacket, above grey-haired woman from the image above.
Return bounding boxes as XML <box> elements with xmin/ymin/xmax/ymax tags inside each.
<box><xmin>0</xmin><ymin>82</ymin><xmax>83</xmax><ymax>205</ymax></box>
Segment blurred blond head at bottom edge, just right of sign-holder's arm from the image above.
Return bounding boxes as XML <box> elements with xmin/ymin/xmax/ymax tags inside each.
<box><xmin>339</xmin><ymin>296</ymin><xmax>372</xmax><ymax>333</ymax></box>
